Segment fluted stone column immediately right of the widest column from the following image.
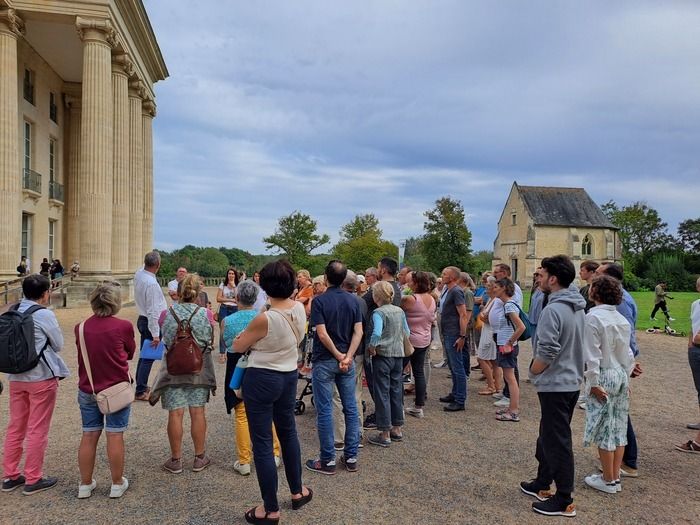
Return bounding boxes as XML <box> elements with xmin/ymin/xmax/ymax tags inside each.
<box><xmin>112</xmin><ymin>54</ymin><xmax>133</xmax><ymax>274</ymax></box>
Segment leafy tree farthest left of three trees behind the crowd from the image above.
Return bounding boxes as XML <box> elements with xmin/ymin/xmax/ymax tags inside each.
<box><xmin>263</xmin><ymin>211</ymin><xmax>330</xmax><ymax>265</ymax></box>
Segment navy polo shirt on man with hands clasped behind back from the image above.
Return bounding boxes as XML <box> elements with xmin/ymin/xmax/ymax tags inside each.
<box><xmin>311</xmin><ymin>286</ymin><xmax>362</xmax><ymax>361</ymax></box>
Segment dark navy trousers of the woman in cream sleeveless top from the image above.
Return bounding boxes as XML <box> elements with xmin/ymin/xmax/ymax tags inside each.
<box><xmin>243</xmin><ymin>368</ymin><xmax>300</xmax><ymax>512</ymax></box>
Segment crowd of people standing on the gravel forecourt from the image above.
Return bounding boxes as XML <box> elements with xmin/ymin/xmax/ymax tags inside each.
<box><xmin>2</xmin><ymin>251</ymin><xmax>700</xmax><ymax>523</ymax></box>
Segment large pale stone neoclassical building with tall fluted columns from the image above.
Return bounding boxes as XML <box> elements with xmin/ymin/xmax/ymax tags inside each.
<box><xmin>0</xmin><ymin>0</ymin><xmax>168</xmax><ymax>281</ymax></box>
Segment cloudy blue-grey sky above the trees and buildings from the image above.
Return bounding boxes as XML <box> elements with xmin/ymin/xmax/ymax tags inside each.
<box><xmin>144</xmin><ymin>0</ymin><xmax>700</xmax><ymax>253</ymax></box>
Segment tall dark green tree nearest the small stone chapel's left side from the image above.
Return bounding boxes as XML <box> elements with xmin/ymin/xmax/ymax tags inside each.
<box><xmin>421</xmin><ymin>197</ymin><xmax>472</xmax><ymax>273</ymax></box>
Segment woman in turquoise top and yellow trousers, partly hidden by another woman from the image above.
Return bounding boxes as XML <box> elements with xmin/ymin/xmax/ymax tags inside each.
<box><xmin>219</xmin><ymin>281</ymin><xmax>280</xmax><ymax>476</ymax></box>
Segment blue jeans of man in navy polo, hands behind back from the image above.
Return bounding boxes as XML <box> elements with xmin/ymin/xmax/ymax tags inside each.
<box><xmin>312</xmin><ymin>359</ymin><xmax>360</xmax><ymax>463</ymax></box>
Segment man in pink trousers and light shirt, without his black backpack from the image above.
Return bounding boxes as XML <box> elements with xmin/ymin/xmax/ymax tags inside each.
<box><xmin>2</xmin><ymin>274</ymin><xmax>70</xmax><ymax>496</ymax></box>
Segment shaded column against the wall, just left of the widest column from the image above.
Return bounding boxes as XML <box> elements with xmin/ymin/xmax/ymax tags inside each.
<box><xmin>64</xmin><ymin>92</ymin><xmax>82</xmax><ymax>268</ymax></box>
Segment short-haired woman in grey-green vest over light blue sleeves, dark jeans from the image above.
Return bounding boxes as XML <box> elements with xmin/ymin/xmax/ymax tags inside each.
<box><xmin>368</xmin><ymin>281</ymin><xmax>411</xmax><ymax>447</ymax></box>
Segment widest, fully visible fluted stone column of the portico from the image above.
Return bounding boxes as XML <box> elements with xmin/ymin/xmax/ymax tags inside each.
<box><xmin>76</xmin><ymin>17</ymin><xmax>114</xmax><ymax>275</ymax></box>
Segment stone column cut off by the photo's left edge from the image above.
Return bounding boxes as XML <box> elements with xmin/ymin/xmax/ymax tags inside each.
<box><xmin>0</xmin><ymin>8</ymin><xmax>24</xmax><ymax>278</ymax></box>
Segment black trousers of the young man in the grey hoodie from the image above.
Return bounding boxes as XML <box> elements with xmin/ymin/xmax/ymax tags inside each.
<box><xmin>535</xmin><ymin>390</ymin><xmax>579</xmax><ymax>501</ymax></box>
